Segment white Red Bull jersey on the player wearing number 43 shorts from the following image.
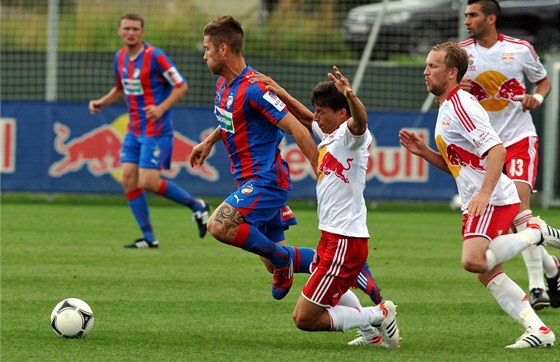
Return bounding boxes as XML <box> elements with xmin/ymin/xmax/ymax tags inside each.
<box><xmin>460</xmin><ymin>34</ymin><xmax>546</xmax><ymax>147</ymax></box>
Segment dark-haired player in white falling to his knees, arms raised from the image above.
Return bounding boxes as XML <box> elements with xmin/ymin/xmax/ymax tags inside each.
<box><xmin>251</xmin><ymin>67</ymin><xmax>400</xmax><ymax>348</ymax></box>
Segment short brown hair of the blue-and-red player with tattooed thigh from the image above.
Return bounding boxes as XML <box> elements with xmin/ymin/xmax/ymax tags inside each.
<box><xmin>204</xmin><ymin>15</ymin><xmax>244</xmax><ymax>54</ymax></box>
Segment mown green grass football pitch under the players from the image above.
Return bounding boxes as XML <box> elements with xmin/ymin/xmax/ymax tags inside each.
<box><xmin>0</xmin><ymin>197</ymin><xmax>560</xmax><ymax>362</ymax></box>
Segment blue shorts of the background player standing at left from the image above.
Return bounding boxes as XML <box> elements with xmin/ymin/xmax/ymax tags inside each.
<box><xmin>121</xmin><ymin>132</ymin><xmax>173</xmax><ymax>170</ymax></box>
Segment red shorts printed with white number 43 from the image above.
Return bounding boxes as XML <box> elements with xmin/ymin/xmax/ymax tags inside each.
<box><xmin>504</xmin><ymin>136</ymin><xmax>539</xmax><ymax>188</ymax></box>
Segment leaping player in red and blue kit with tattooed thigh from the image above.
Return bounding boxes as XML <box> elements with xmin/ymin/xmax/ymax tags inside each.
<box><xmin>190</xmin><ymin>16</ymin><xmax>318</xmax><ymax>299</ymax></box>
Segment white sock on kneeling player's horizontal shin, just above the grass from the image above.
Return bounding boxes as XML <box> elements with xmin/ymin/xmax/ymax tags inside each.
<box><xmin>327</xmin><ymin>305</ymin><xmax>385</xmax><ymax>332</ymax></box>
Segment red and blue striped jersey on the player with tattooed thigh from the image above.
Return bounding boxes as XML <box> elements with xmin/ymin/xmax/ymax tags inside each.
<box><xmin>214</xmin><ymin>67</ymin><xmax>292</xmax><ymax>190</ymax></box>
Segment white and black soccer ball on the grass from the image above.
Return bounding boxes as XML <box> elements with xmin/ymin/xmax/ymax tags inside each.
<box><xmin>51</xmin><ymin>298</ymin><xmax>93</xmax><ymax>338</ymax></box>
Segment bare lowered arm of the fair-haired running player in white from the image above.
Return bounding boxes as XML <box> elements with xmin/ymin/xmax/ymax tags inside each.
<box><xmin>468</xmin><ymin>144</ymin><xmax>506</xmax><ymax>216</ymax></box>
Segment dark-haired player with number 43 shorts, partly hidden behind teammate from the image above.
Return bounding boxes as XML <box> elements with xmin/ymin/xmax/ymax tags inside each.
<box><xmin>460</xmin><ymin>0</ymin><xmax>560</xmax><ymax>310</ymax></box>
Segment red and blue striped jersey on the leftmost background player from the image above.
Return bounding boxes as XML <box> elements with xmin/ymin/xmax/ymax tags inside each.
<box><xmin>115</xmin><ymin>43</ymin><xmax>186</xmax><ymax>137</ymax></box>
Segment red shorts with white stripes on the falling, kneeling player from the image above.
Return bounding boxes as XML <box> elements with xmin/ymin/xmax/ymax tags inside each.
<box><xmin>302</xmin><ymin>231</ymin><xmax>368</xmax><ymax>307</ymax></box>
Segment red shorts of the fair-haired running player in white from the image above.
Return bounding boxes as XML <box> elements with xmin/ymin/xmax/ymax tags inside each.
<box><xmin>462</xmin><ymin>204</ymin><xmax>520</xmax><ymax>241</ymax></box>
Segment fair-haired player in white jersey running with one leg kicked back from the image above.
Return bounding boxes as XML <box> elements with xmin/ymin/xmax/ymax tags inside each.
<box><xmin>399</xmin><ymin>42</ymin><xmax>560</xmax><ymax>348</ymax></box>
